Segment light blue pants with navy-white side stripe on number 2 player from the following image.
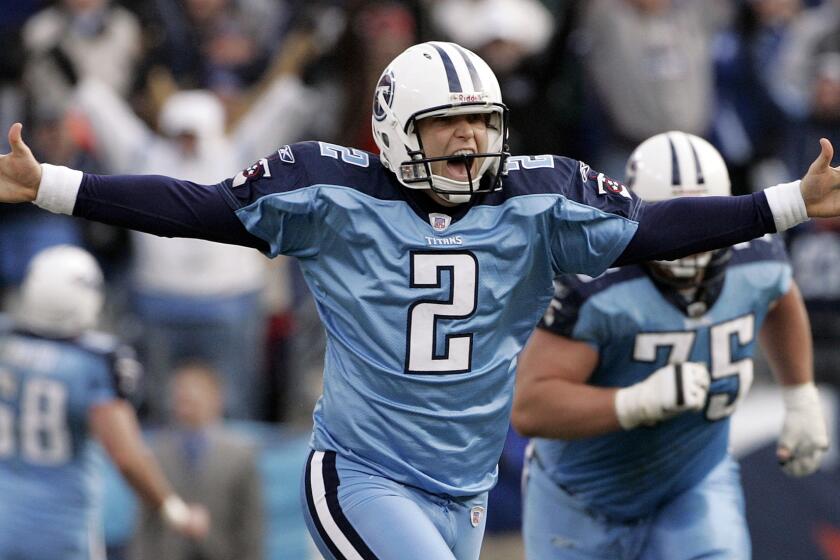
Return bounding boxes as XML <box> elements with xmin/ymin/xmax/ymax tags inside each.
<box><xmin>301</xmin><ymin>451</ymin><xmax>487</xmax><ymax>560</ymax></box>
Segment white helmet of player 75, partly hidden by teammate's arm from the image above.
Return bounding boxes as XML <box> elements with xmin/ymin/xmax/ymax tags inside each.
<box><xmin>625</xmin><ymin>131</ymin><xmax>732</xmax><ymax>288</ymax></box>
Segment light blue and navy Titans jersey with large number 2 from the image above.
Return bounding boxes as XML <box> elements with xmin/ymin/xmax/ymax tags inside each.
<box><xmin>220</xmin><ymin>142</ymin><xmax>639</xmax><ymax>496</ymax></box>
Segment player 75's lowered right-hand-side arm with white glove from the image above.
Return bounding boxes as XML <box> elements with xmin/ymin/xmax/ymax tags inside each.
<box><xmin>759</xmin><ymin>284</ymin><xmax>828</xmax><ymax>476</ymax></box>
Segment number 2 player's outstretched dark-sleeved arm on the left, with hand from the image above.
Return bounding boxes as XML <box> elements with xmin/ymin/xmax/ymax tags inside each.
<box><xmin>0</xmin><ymin>123</ymin><xmax>267</xmax><ymax>250</ymax></box>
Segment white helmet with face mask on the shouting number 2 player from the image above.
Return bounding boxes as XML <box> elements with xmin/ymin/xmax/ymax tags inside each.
<box><xmin>371</xmin><ymin>42</ymin><xmax>509</xmax><ymax>203</ymax></box>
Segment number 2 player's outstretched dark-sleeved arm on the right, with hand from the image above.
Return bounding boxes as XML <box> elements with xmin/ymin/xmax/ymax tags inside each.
<box><xmin>614</xmin><ymin>138</ymin><xmax>840</xmax><ymax>266</ymax></box>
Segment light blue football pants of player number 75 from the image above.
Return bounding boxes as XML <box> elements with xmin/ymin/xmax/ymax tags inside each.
<box><xmin>523</xmin><ymin>450</ymin><xmax>750</xmax><ymax>560</ymax></box>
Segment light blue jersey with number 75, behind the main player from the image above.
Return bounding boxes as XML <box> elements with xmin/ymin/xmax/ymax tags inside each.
<box><xmin>534</xmin><ymin>236</ymin><xmax>791</xmax><ymax>520</ymax></box>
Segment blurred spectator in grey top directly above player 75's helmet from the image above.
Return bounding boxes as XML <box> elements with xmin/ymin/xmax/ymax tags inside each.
<box><xmin>581</xmin><ymin>0</ymin><xmax>730</xmax><ymax>177</ymax></box>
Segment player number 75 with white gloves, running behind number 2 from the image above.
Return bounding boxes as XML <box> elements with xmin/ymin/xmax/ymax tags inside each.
<box><xmin>513</xmin><ymin>132</ymin><xmax>828</xmax><ymax>560</ymax></box>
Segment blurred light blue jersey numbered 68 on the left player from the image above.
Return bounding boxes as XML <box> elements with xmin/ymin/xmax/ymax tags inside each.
<box><xmin>0</xmin><ymin>324</ymin><xmax>136</xmax><ymax>560</ymax></box>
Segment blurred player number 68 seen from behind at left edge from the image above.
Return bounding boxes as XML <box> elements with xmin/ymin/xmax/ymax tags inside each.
<box><xmin>0</xmin><ymin>246</ymin><xmax>208</xmax><ymax>560</ymax></box>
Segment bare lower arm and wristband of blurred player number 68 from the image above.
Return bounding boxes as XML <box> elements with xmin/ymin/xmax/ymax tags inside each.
<box><xmin>89</xmin><ymin>399</ymin><xmax>210</xmax><ymax>538</ymax></box>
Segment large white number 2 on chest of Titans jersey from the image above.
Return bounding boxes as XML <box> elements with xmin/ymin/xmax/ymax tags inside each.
<box><xmin>405</xmin><ymin>251</ymin><xmax>478</xmax><ymax>374</ymax></box>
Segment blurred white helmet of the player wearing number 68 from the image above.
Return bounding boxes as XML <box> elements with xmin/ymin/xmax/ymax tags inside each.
<box><xmin>18</xmin><ymin>245</ymin><xmax>104</xmax><ymax>337</ymax></box>
